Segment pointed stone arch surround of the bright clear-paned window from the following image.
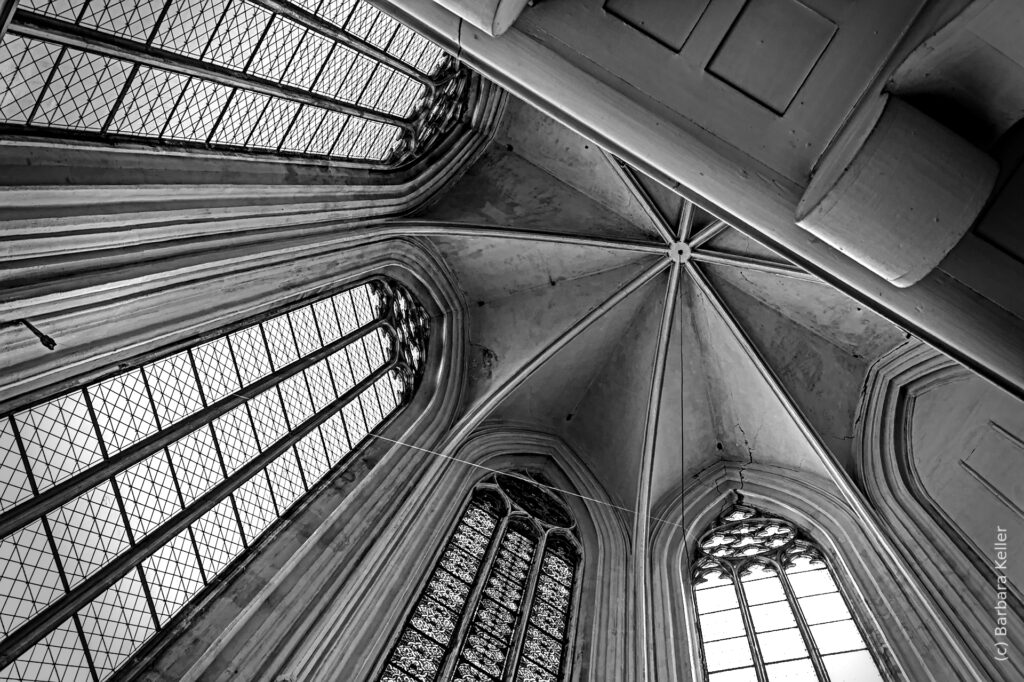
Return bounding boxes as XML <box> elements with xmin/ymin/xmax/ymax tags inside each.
<box><xmin>652</xmin><ymin>463</ymin><xmax>978</xmax><ymax>680</ymax></box>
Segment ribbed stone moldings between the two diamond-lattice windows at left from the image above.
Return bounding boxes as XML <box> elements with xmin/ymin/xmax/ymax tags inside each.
<box><xmin>0</xmin><ymin>77</ymin><xmax>507</xmax><ymax>408</ymax></box>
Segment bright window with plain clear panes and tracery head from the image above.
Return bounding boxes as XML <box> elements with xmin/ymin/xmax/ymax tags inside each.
<box><xmin>693</xmin><ymin>506</ymin><xmax>882</xmax><ymax>682</ymax></box>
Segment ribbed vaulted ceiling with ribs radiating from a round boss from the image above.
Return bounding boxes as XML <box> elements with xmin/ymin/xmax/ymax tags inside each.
<box><xmin>414</xmin><ymin>95</ymin><xmax>906</xmax><ymax>518</ymax></box>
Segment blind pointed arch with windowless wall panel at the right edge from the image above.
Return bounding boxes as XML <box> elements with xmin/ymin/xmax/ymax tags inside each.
<box><xmin>854</xmin><ymin>340</ymin><xmax>1024</xmax><ymax>680</ymax></box>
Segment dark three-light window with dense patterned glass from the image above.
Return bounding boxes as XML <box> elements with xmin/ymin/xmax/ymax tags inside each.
<box><xmin>378</xmin><ymin>473</ymin><xmax>582</xmax><ymax>682</ymax></box>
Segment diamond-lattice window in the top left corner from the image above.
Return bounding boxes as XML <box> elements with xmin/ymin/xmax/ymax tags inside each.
<box><xmin>0</xmin><ymin>0</ymin><xmax>466</xmax><ymax>165</ymax></box>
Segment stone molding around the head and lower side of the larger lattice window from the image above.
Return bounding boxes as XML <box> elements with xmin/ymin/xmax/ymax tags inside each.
<box><xmin>125</xmin><ymin>233</ymin><xmax>466</xmax><ymax>682</ymax></box>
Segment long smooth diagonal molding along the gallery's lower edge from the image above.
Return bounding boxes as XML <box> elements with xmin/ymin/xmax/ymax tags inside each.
<box><xmin>376</xmin><ymin>0</ymin><xmax>1024</xmax><ymax>395</ymax></box>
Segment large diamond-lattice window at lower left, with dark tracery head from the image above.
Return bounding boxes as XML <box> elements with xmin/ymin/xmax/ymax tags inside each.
<box><xmin>0</xmin><ymin>279</ymin><xmax>428</xmax><ymax>680</ymax></box>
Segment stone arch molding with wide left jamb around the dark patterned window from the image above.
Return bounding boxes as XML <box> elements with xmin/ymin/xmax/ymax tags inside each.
<box><xmin>148</xmin><ymin>428</ymin><xmax>633</xmax><ymax>682</ymax></box>
